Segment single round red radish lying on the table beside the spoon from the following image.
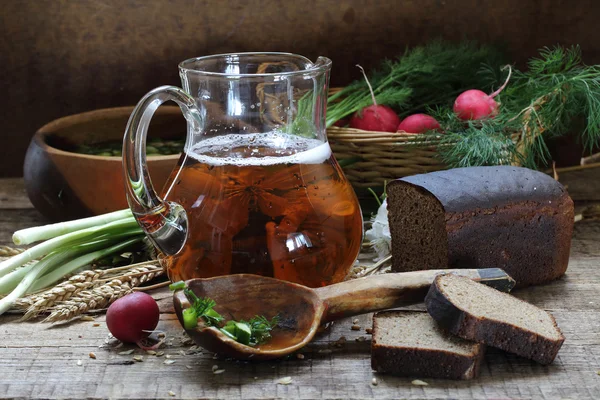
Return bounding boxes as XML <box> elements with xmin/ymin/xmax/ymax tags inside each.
<box><xmin>106</xmin><ymin>292</ymin><xmax>160</xmax><ymax>343</ymax></box>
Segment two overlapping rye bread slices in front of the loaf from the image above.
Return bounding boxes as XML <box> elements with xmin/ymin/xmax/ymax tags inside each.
<box><xmin>371</xmin><ymin>274</ymin><xmax>565</xmax><ymax>379</ymax></box>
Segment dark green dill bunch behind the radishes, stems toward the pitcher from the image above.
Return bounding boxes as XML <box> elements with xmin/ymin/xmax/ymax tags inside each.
<box><xmin>327</xmin><ymin>40</ymin><xmax>504</xmax><ymax>127</ymax></box>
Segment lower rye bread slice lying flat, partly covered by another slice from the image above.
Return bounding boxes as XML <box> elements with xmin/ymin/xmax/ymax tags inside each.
<box><xmin>371</xmin><ymin>311</ymin><xmax>485</xmax><ymax>379</ymax></box>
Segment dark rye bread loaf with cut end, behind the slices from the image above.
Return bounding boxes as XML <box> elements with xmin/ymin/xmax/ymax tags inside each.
<box><xmin>387</xmin><ymin>166</ymin><xmax>574</xmax><ymax>287</ymax></box>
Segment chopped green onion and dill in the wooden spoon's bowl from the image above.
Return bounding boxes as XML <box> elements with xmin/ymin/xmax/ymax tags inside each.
<box><xmin>169</xmin><ymin>282</ymin><xmax>279</xmax><ymax>346</ymax></box>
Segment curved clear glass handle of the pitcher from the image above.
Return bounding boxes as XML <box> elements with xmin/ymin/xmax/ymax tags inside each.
<box><xmin>123</xmin><ymin>86</ymin><xmax>202</xmax><ymax>255</ymax></box>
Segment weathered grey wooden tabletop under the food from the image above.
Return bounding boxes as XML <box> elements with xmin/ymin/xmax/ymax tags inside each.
<box><xmin>0</xmin><ymin>179</ymin><xmax>600</xmax><ymax>399</ymax></box>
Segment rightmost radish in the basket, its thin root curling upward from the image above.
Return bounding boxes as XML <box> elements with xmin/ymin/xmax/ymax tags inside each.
<box><xmin>454</xmin><ymin>66</ymin><xmax>512</xmax><ymax>121</ymax></box>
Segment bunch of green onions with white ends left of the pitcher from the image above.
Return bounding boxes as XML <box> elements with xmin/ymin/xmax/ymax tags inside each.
<box><xmin>0</xmin><ymin>209</ymin><xmax>145</xmax><ymax>314</ymax></box>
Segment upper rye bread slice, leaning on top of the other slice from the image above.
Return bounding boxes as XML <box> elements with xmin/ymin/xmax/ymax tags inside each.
<box><xmin>425</xmin><ymin>274</ymin><xmax>565</xmax><ymax>364</ymax></box>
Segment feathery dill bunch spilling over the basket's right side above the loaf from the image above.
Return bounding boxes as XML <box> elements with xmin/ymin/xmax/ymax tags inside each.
<box><xmin>429</xmin><ymin>46</ymin><xmax>600</xmax><ymax>168</ymax></box>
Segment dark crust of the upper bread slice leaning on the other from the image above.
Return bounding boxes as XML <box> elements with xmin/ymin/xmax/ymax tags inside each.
<box><xmin>425</xmin><ymin>275</ymin><xmax>565</xmax><ymax>365</ymax></box>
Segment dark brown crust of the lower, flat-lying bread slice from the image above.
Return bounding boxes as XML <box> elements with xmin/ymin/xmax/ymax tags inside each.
<box><xmin>371</xmin><ymin>311</ymin><xmax>485</xmax><ymax>380</ymax></box>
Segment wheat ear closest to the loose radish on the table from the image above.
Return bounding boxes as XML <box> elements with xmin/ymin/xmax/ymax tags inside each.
<box><xmin>44</xmin><ymin>266</ymin><xmax>164</xmax><ymax>322</ymax></box>
